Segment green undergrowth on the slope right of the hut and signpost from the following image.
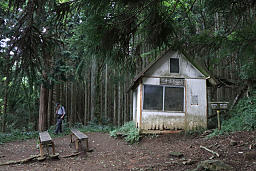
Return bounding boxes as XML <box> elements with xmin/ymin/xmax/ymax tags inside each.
<box><xmin>209</xmin><ymin>92</ymin><xmax>256</xmax><ymax>137</ymax></box>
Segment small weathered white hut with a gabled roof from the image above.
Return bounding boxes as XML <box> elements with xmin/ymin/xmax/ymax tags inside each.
<box><xmin>129</xmin><ymin>50</ymin><xmax>213</xmax><ymax>133</ymax></box>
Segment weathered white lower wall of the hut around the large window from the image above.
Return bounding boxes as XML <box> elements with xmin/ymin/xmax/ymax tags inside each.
<box><xmin>137</xmin><ymin>78</ymin><xmax>207</xmax><ymax>132</ymax></box>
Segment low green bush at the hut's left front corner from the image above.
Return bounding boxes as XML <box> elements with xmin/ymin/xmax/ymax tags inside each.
<box><xmin>110</xmin><ymin>121</ymin><xmax>140</xmax><ymax>144</ymax></box>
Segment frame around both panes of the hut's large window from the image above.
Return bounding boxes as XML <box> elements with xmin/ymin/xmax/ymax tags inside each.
<box><xmin>142</xmin><ymin>84</ymin><xmax>186</xmax><ymax>113</ymax></box>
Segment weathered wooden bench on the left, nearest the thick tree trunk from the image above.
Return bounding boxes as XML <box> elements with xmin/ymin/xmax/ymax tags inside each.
<box><xmin>39</xmin><ymin>131</ymin><xmax>55</xmax><ymax>158</ymax></box>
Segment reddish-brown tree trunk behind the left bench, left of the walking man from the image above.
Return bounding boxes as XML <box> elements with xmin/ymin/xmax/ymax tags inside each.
<box><xmin>38</xmin><ymin>84</ymin><xmax>49</xmax><ymax>132</ymax></box>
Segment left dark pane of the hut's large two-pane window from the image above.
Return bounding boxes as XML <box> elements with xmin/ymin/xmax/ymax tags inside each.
<box><xmin>143</xmin><ymin>85</ymin><xmax>163</xmax><ymax>110</ymax></box>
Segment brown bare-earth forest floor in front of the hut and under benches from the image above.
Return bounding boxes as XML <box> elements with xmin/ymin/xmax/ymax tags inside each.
<box><xmin>0</xmin><ymin>131</ymin><xmax>256</xmax><ymax>171</ymax></box>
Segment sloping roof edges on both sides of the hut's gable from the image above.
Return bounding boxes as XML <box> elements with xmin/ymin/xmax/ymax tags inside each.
<box><xmin>128</xmin><ymin>49</ymin><xmax>217</xmax><ymax>91</ymax></box>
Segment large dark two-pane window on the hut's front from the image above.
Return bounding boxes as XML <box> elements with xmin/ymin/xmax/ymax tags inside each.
<box><xmin>143</xmin><ymin>85</ymin><xmax>184</xmax><ymax>111</ymax></box>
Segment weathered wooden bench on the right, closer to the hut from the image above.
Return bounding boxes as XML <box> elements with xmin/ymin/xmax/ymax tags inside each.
<box><xmin>70</xmin><ymin>128</ymin><xmax>89</xmax><ymax>152</ymax></box>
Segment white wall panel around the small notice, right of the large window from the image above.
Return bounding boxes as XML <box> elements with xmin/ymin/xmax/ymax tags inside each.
<box><xmin>186</xmin><ymin>79</ymin><xmax>207</xmax><ymax>129</ymax></box>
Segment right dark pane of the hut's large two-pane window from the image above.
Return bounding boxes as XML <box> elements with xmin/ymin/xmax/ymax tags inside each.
<box><xmin>164</xmin><ymin>87</ymin><xmax>184</xmax><ymax>111</ymax></box>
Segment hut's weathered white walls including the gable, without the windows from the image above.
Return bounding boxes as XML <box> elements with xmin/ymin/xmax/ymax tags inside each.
<box><xmin>134</xmin><ymin>52</ymin><xmax>207</xmax><ymax>132</ymax></box>
